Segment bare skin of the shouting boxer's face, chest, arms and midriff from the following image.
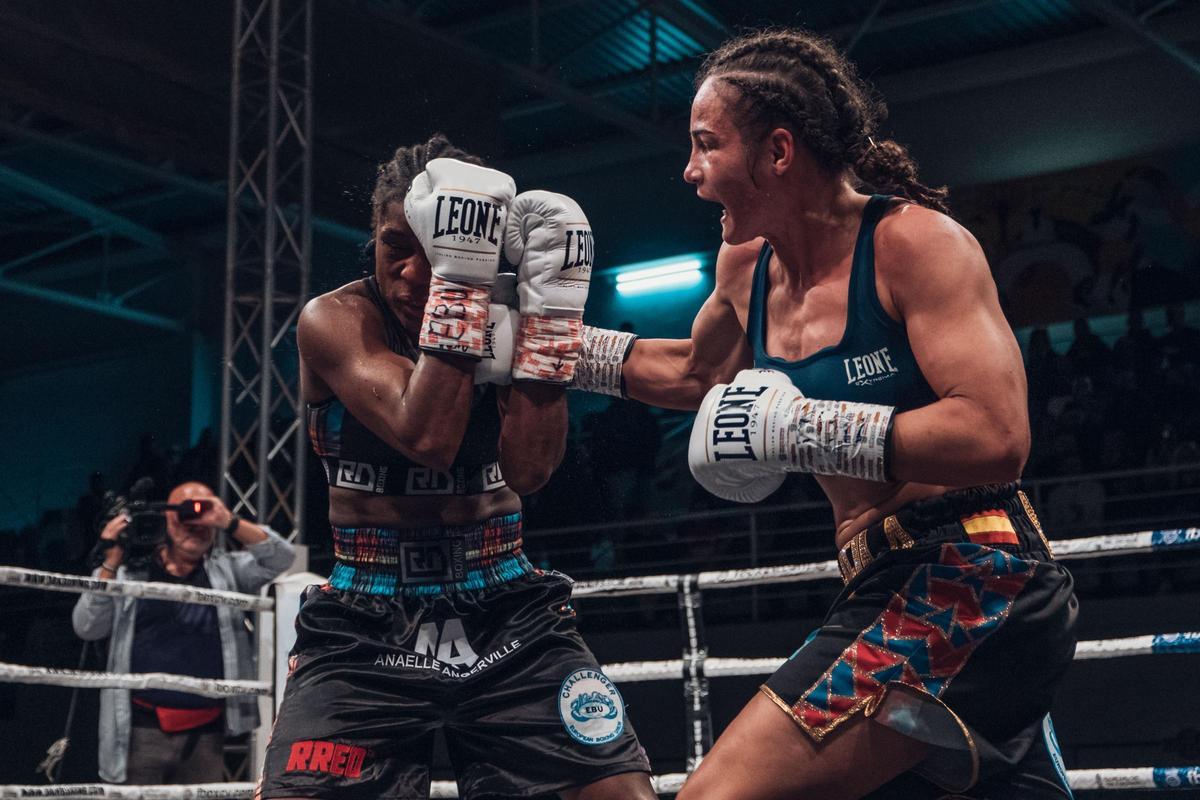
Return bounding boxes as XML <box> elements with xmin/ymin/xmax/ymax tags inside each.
<box><xmin>624</xmin><ymin>79</ymin><xmax>1030</xmax><ymax>547</ymax></box>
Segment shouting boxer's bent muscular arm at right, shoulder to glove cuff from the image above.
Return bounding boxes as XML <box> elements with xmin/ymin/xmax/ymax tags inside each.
<box><xmin>876</xmin><ymin>206</ymin><xmax>1030</xmax><ymax>486</ymax></box>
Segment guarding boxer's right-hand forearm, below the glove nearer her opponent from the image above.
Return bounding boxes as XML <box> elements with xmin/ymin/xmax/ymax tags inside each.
<box><xmin>499</xmin><ymin>380</ymin><xmax>566</xmax><ymax>494</ymax></box>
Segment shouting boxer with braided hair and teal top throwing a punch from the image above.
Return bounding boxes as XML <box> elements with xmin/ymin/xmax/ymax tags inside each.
<box><xmin>574</xmin><ymin>30</ymin><xmax>1076</xmax><ymax>800</ymax></box>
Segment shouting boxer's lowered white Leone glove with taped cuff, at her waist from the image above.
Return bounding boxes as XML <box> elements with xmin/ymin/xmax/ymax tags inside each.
<box><xmin>688</xmin><ymin>369</ymin><xmax>895</xmax><ymax>503</ymax></box>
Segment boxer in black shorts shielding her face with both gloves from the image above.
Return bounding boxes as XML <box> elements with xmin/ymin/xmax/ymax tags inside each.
<box><xmin>260</xmin><ymin>136</ymin><xmax>654</xmax><ymax>800</ymax></box>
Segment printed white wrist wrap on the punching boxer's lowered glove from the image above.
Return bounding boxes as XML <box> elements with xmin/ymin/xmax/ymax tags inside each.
<box><xmin>784</xmin><ymin>397</ymin><xmax>895</xmax><ymax>481</ymax></box>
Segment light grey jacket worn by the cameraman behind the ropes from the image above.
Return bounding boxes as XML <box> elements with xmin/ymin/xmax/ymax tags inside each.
<box><xmin>71</xmin><ymin>525</ymin><xmax>295</xmax><ymax>783</ymax></box>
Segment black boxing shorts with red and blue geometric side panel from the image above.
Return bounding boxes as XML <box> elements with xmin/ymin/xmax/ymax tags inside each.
<box><xmin>761</xmin><ymin>485</ymin><xmax>1078</xmax><ymax>800</ymax></box>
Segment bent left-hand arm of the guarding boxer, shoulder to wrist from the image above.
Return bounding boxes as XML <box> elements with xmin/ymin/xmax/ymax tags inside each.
<box><xmin>298</xmin><ymin>293</ymin><xmax>475</xmax><ymax>470</ymax></box>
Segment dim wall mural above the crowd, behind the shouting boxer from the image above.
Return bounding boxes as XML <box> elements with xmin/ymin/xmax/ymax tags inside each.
<box><xmin>950</xmin><ymin>155</ymin><xmax>1200</xmax><ymax>327</ymax></box>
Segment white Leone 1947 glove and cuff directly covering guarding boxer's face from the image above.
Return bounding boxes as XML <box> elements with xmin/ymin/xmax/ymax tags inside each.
<box><xmin>404</xmin><ymin>158</ymin><xmax>516</xmax><ymax>359</ymax></box>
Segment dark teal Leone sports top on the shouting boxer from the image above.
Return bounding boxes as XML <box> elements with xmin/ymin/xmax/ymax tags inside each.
<box><xmin>746</xmin><ymin>194</ymin><xmax>937</xmax><ymax>411</ymax></box>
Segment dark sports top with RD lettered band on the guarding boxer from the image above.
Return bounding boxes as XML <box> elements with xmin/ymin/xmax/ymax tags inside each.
<box><xmin>307</xmin><ymin>277</ymin><xmax>504</xmax><ymax>495</ymax></box>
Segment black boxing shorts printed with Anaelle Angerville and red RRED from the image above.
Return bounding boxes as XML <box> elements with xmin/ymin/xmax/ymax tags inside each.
<box><xmin>259</xmin><ymin>571</ymin><xmax>649</xmax><ymax>800</ymax></box>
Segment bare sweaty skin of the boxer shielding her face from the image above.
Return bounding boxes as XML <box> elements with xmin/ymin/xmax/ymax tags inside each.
<box><xmin>298</xmin><ymin>203</ymin><xmax>566</xmax><ymax>528</ymax></box>
